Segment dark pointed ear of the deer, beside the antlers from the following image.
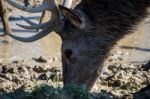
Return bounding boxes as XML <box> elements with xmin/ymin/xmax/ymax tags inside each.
<box><xmin>59</xmin><ymin>5</ymin><xmax>85</xmax><ymax>29</ymax></box>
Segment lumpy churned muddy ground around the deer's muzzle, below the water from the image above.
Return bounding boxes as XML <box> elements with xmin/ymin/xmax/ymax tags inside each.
<box><xmin>0</xmin><ymin>51</ymin><xmax>150</xmax><ymax>99</ymax></box>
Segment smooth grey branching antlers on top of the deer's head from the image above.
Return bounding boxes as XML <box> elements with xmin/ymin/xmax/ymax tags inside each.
<box><xmin>7</xmin><ymin>0</ymin><xmax>72</xmax><ymax>42</ymax></box>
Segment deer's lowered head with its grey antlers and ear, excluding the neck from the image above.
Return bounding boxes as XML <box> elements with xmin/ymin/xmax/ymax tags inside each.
<box><xmin>7</xmin><ymin>0</ymin><xmax>101</xmax><ymax>87</ymax></box>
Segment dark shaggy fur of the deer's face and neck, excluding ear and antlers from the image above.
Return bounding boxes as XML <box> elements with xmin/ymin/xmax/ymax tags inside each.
<box><xmin>59</xmin><ymin>0</ymin><xmax>150</xmax><ymax>89</ymax></box>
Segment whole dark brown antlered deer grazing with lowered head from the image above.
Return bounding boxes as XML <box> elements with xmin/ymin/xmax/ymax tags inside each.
<box><xmin>7</xmin><ymin>0</ymin><xmax>150</xmax><ymax>89</ymax></box>
